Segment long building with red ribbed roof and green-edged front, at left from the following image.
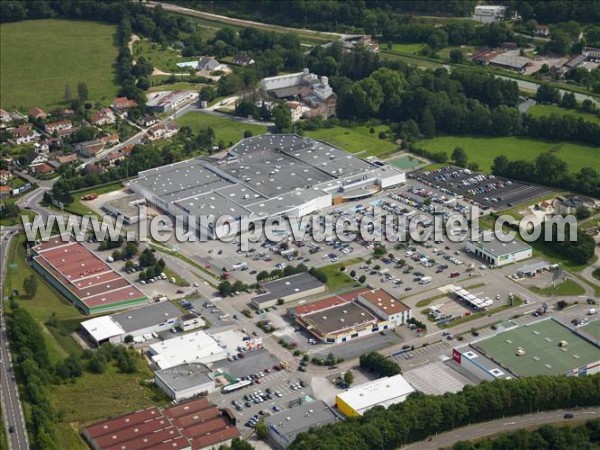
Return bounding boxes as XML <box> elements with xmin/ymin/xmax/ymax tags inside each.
<box><xmin>28</xmin><ymin>236</ymin><xmax>147</xmax><ymax>314</ymax></box>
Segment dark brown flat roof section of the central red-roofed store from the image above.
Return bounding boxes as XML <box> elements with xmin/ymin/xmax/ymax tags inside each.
<box><xmin>302</xmin><ymin>302</ymin><xmax>379</xmax><ymax>336</ymax></box>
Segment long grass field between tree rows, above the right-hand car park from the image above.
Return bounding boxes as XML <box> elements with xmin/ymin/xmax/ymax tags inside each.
<box><xmin>418</xmin><ymin>136</ymin><xmax>598</xmax><ymax>173</ymax></box>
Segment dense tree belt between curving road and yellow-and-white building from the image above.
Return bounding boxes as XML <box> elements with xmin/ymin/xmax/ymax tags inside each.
<box><xmin>289</xmin><ymin>374</ymin><xmax>600</xmax><ymax>450</ymax></box>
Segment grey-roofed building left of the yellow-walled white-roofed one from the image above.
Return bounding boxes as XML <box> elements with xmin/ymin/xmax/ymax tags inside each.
<box><xmin>265</xmin><ymin>400</ymin><xmax>340</xmax><ymax>448</ymax></box>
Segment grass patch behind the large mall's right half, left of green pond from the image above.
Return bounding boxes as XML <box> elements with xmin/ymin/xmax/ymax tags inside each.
<box><xmin>304</xmin><ymin>125</ymin><xmax>398</xmax><ymax>157</ymax></box>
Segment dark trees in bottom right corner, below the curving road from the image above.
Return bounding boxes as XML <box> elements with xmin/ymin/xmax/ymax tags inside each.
<box><xmin>452</xmin><ymin>419</ymin><xmax>600</xmax><ymax>450</ymax></box>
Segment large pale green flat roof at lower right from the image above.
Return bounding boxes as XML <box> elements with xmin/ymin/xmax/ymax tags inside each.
<box><xmin>475</xmin><ymin>319</ymin><xmax>600</xmax><ymax>376</ymax></box>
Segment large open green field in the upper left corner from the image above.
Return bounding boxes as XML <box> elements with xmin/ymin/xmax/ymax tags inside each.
<box><xmin>0</xmin><ymin>20</ymin><xmax>118</xmax><ymax>111</ymax></box>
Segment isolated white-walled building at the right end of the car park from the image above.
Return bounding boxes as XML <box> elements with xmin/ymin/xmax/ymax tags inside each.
<box><xmin>466</xmin><ymin>231</ymin><xmax>533</xmax><ymax>267</ymax></box>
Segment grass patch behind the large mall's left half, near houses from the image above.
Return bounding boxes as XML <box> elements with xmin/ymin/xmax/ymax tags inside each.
<box><xmin>177</xmin><ymin>112</ymin><xmax>267</xmax><ymax>146</ymax></box>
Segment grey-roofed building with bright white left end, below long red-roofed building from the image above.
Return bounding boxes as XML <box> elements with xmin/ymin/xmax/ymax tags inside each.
<box><xmin>81</xmin><ymin>301</ymin><xmax>181</xmax><ymax>346</ymax></box>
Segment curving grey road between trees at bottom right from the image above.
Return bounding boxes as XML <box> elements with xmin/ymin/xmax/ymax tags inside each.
<box><xmin>402</xmin><ymin>407</ymin><xmax>600</xmax><ymax>449</ymax></box>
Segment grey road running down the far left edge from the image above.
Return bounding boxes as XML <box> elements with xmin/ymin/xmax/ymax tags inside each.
<box><xmin>0</xmin><ymin>231</ymin><xmax>29</xmax><ymax>450</ymax></box>
